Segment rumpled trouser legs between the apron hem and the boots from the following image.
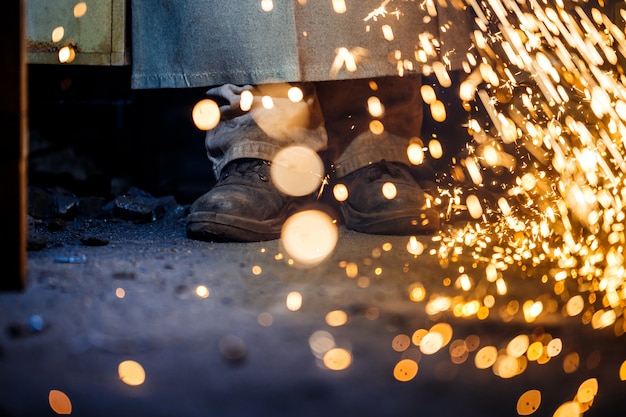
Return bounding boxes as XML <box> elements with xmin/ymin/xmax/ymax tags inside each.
<box><xmin>206</xmin><ymin>74</ymin><xmax>422</xmax><ymax>178</ymax></box>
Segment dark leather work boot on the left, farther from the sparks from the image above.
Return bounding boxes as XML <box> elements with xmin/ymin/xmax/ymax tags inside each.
<box><xmin>187</xmin><ymin>159</ymin><xmax>293</xmax><ymax>242</ymax></box>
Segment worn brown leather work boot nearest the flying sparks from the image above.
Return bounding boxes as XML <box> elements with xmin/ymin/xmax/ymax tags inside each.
<box><xmin>338</xmin><ymin>161</ymin><xmax>439</xmax><ymax>236</ymax></box>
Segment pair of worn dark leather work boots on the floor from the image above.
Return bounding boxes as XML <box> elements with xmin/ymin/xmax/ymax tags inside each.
<box><xmin>187</xmin><ymin>159</ymin><xmax>439</xmax><ymax>242</ymax></box>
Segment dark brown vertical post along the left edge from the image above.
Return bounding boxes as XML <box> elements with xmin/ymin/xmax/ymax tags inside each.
<box><xmin>0</xmin><ymin>0</ymin><xmax>28</xmax><ymax>291</ymax></box>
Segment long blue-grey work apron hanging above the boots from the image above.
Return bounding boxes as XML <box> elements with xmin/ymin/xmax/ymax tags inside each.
<box><xmin>130</xmin><ymin>0</ymin><xmax>474</xmax><ymax>89</ymax></box>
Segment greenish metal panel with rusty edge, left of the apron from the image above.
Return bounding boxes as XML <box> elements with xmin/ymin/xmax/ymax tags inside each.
<box><xmin>26</xmin><ymin>0</ymin><xmax>128</xmax><ymax>65</ymax></box>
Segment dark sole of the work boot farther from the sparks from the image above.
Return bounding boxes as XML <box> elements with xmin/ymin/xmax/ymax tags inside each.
<box><xmin>187</xmin><ymin>211</ymin><xmax>283</xmax><ymax>242</ymax></box>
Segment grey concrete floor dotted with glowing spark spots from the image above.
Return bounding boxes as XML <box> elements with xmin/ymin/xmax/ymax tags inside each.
<box><xmin>0</xmin><ymin>213</ymin><xmax>626</xmax><ymax>417</ymax></box>
